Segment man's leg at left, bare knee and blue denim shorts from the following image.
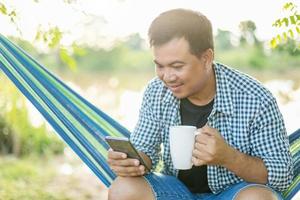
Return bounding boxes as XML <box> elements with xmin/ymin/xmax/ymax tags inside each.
<box><xmin>108</xmin><ymin>173</ymin><xmax>195</xmax><ymax>200</ymax></box>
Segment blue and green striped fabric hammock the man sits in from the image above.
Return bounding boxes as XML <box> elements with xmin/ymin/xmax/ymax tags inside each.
<box><xmin>0</xmin><ymin>34</ymin><xmax>300</xmax><ymax>199</ymax></box>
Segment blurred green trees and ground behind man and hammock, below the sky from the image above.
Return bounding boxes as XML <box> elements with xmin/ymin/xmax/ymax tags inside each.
<box><xmin>0</xmin><ymin>1</ymin><xmax>300</xmax><ymax>199</ymax></box>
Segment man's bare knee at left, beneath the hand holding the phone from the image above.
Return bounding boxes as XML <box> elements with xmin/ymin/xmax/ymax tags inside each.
<box><xmin>108</xmin><ymin>177</ymin><xmax>154</xmax><ymax>200</ymax></box>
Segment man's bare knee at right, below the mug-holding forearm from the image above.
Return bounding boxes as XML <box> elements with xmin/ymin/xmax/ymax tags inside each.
<box><xmin>235</xmin><ymin>186</ymin><xmax>278</xmax><ymax>200</ymax></box>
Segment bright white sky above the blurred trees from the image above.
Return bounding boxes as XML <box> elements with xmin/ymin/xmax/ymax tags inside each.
<box><xmin>0</xmin><ymin>0</ymin><xmax>300</xmax><ymax>46</ymax></box>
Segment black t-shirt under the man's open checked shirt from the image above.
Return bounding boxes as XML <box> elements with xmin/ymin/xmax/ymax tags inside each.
<box><xmin>178</xmin><ymin>99</ymin><xmax>214</xmax><ymax>193</ymax></box>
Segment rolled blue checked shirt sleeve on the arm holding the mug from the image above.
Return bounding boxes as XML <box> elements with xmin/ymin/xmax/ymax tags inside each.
<box><xmin>250</xmin><ymin>98</ymin><xmax>293</xmax><ymax>191</ymax></box>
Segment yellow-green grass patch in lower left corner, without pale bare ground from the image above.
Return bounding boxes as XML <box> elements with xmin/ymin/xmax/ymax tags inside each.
<box><xmin>0</xmin><ymin>157</ymin><xmax>66</xmax><ymax>200</ymax></box>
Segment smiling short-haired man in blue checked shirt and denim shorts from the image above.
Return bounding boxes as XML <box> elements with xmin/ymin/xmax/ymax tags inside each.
<box><xmin>108</xmin><ymin>9</ymin><xmax>292</xmax><ymax>200</ymax></box>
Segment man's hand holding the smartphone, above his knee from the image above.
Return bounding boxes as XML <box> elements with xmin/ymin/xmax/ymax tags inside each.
<box><xmin>107</xmin><ymin>149</ymin><xmax>146</xmax><ymax>177</ymax></box>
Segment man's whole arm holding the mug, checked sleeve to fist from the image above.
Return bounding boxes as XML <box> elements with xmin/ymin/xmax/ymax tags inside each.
<box><xmin>193</xmin><ymin>99</ymin><xmax>293</xmax><ymax>191</ymax></box>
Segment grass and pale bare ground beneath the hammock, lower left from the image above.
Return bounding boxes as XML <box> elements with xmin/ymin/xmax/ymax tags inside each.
<box><xmin>0</xmin><ymin>155</ymin><xmax>107</xmax><ymax>200</ymax></box>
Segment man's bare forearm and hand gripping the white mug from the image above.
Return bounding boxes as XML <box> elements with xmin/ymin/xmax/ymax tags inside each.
<box><xmin>193</xmin><ymin>125</ymin><xmax>268</xmax><ymax>184</ymax></box>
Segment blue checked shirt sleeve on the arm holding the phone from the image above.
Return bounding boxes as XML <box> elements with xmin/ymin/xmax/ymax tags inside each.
<box><xmin>130</xmin><ymin>84</ymin><xmax>161</xmax><ymax>170</ymax></box>
